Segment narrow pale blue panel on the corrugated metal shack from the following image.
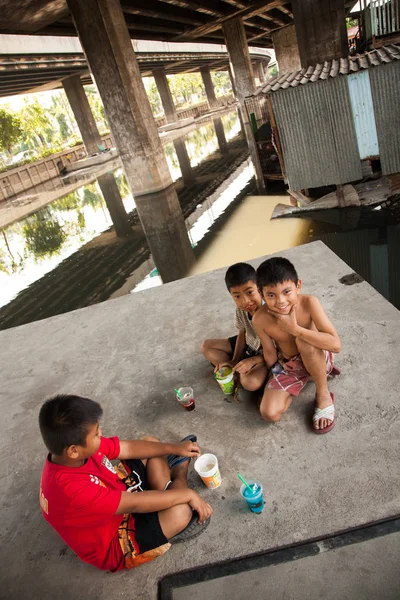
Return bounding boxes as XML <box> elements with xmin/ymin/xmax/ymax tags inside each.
<box><xmin>347</xmin><ymin>70</ymin><xmax>379</xmax><ymax>160</ymax></box>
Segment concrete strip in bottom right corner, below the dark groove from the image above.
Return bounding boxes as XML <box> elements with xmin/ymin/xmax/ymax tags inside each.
<box><xmin>172</xmin><ymin>533</ymin><xmax>400</xmax><ymax>600</ymax></box>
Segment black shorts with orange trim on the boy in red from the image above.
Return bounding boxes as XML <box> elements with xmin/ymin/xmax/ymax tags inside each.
<box><xmin>117</xmin><ymin>459</ymin><xmax>170</xmax><ymax>569</ymax></box>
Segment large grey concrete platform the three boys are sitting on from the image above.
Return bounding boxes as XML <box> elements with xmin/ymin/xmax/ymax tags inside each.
<box><xmin>0</xmin><ymin>242</ymin><xmax>400</xmax><ymax>600</ymax></box>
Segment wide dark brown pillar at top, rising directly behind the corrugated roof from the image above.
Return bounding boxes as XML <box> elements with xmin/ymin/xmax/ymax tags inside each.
<box><xmin>290</xmin><ymin>0</ymin><xmax>349</xmax><ymax>71</ymax></box>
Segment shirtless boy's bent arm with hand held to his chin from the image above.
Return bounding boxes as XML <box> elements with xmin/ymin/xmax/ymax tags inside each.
<box><xmin>292</xmin><ymin>296</ymin><xmax>342</xmax><ymax>353</ymax></box>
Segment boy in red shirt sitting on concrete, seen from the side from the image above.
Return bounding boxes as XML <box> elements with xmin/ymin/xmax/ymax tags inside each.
<box><xmin>39</xmin><ymin>395</ymin><xmax>212</xmax><ymax>571</ymax></box>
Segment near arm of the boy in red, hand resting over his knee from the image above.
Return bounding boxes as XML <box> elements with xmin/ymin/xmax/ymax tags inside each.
<box><xmin>115</xmin><ymin>488</ymin><xmax>213</xmax><ymax>523</ymax></box>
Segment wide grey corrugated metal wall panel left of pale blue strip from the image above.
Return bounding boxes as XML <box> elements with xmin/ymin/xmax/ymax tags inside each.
<box><xmin>271</xmin><ymin>77</ymin><xmax>362</xmax><ymax>190</ymax></box>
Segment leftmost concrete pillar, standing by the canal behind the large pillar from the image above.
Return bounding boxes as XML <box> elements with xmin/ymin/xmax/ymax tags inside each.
<box><xmin>62</xmin><ymin>75</ymin><xmax>102</xmax><ymax>155</ymax></box>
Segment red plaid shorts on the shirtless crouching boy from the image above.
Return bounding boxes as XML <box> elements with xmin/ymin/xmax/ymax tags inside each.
<box><xmin>267</xmin><ymin>350</ymin><xmax>333</xmax><ymax>396</ymax></box>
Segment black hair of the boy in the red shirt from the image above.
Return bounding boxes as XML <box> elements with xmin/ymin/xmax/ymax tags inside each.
<box><xmin>39</xmin><ymin>395</ymin><xmax>103</xmax><ymax>456</ymax></box>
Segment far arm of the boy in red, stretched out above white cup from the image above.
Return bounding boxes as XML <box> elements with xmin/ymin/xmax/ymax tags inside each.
<box><xmin>117</xmin><ymin>440</ymin><xmax>200</xmax><ymax>460</ymax></box>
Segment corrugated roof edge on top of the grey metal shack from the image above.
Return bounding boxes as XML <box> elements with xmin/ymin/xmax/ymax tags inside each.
<box><xmin>256</xmin><ymin>44</ymin><xmax>400</xmax><ymax>95</ymax></box>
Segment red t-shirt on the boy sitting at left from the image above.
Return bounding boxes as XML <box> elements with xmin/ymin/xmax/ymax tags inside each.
<box><xmin>40</xmin><ymin>437</ymin><xmax>126</xmax><ymax>571</ymax></box>
